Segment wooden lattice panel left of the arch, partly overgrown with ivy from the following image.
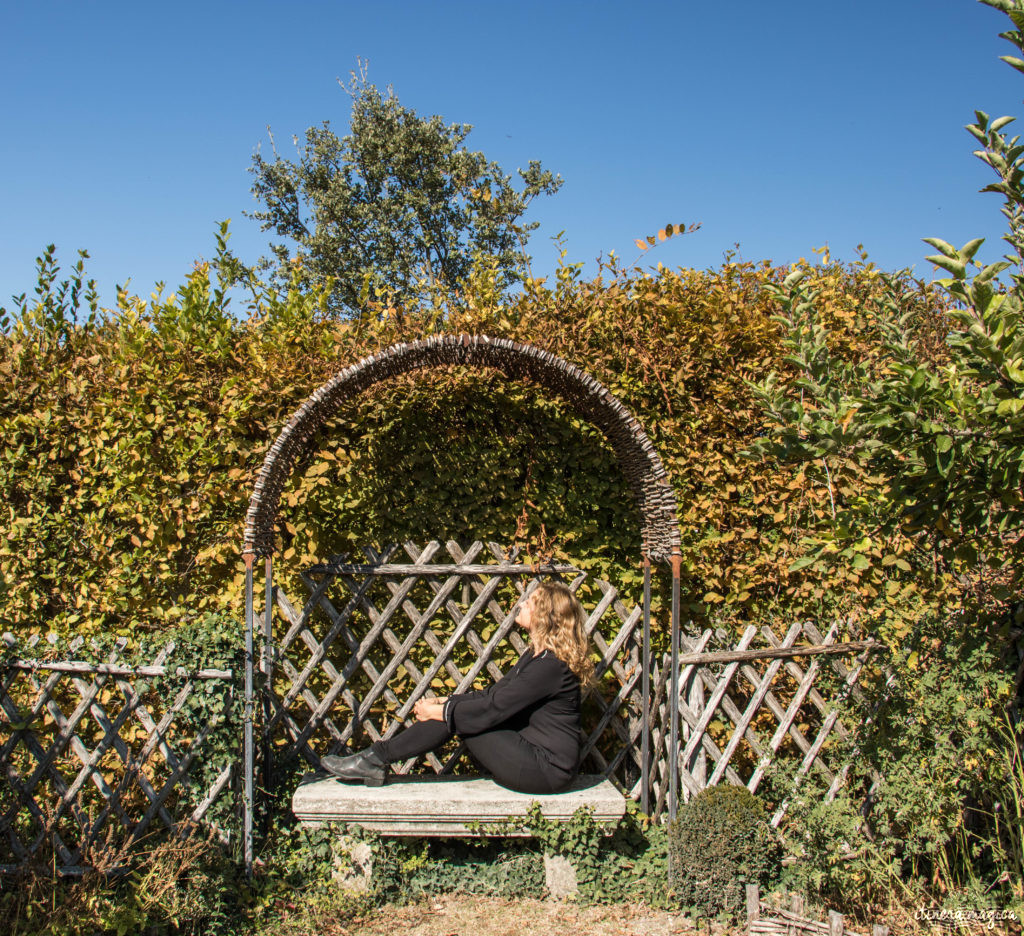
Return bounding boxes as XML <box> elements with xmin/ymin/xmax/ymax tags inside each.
<box><xmin>0</xmin><ymin>635</ymin><xmax>234</xmax><ymax>873</ymax></box>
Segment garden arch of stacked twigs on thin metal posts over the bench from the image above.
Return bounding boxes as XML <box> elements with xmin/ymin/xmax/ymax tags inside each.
<box><xmin>242</xmin><ymin>335</ymin><xmax>682</xmax><ymax>875</ymax></box>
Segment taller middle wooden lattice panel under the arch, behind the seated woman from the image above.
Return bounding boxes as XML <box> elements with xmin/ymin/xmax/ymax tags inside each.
<box><xmin>268</xmin><ymin>542</ymin><xmax>642</xmax><ymax>791</ymax></box>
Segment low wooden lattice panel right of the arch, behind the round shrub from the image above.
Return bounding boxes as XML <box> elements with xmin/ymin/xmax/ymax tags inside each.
<box><xmin>651</xmin><ymin>622</ymin><xmax>888</xmax><ymax>825</ymax></box>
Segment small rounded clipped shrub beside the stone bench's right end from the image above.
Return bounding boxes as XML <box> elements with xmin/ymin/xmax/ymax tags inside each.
<box><xmin>669</xmin><ymin>784</ymin><xmax>781</xmax><ymax>916</ymax></box>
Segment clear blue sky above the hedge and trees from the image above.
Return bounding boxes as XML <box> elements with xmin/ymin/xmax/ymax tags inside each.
<box><xmin>0</xmin><ymin>0</ymin><xmax>1024</xmax><ymax>306</ymax></box>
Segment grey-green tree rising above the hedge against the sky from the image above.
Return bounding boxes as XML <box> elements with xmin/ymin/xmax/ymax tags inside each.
<box><xmin>250</xmin><ymin>68</ymin><xmax>562</xmax><ymax>314</ymax></box>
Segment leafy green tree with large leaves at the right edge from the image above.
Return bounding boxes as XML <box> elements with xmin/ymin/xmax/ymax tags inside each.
<box><xmin>754</xmin><ymin>0</ymin><xmax>1024</xmax><ymax>594</ymax></box>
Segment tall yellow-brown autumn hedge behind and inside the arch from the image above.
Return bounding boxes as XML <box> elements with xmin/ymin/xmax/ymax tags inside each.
<box><xmin>0</xmin><ymin>230</ymin><xmax>970</xmax><ymax>651</ymax></box>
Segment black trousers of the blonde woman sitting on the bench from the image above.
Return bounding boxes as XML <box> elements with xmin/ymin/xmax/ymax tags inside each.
<box><xmin>372</xmin><ymin>719</ymin><xmax>573</xmax><ymax>793</ymax></box>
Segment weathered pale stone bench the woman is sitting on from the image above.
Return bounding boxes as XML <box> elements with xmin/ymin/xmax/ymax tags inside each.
<box><xmin>292</xmin><ymin>774</ymin><xmax>626</xmax><ymax>897</ymax></box>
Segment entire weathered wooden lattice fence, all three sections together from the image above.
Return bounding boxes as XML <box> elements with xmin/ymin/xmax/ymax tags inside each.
<box><xmin>0</xmin><ymin>542</ymin><xmax>905</xmax><ymax>871</ymax></box>
